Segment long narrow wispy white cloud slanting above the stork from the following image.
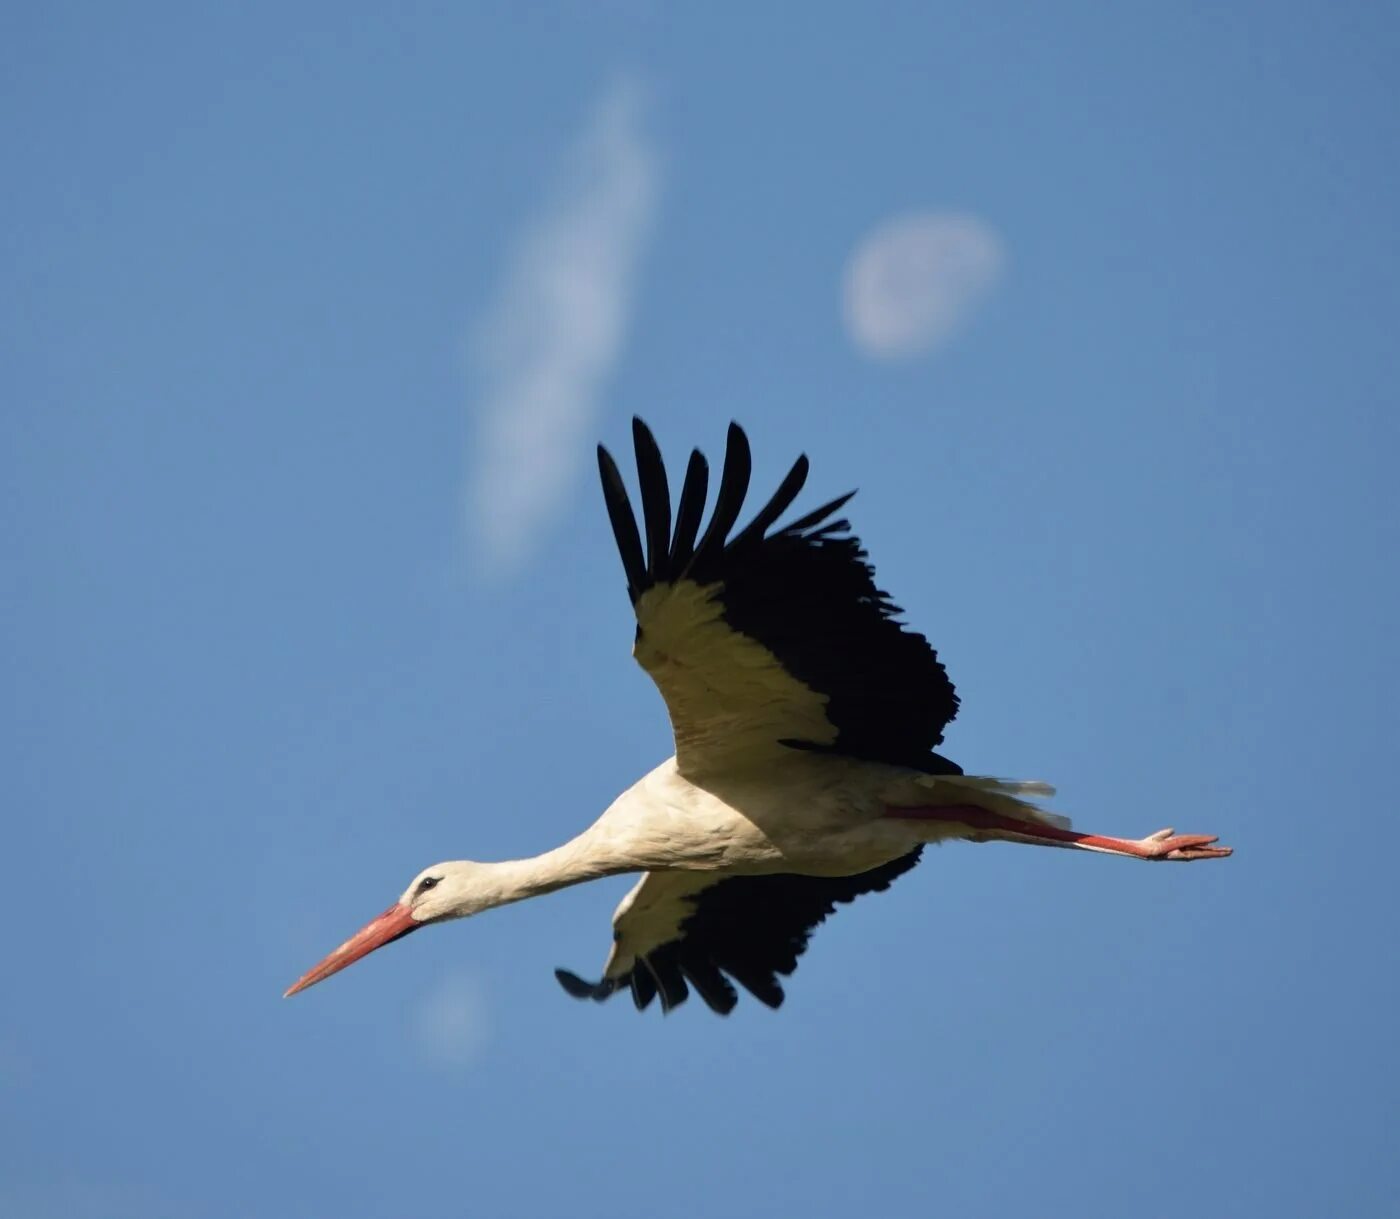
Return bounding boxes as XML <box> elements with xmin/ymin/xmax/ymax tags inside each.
<box><xmin>466</xmin><ymin>81</ymin><xmax>658</xmax><ymax>574</ymax></box>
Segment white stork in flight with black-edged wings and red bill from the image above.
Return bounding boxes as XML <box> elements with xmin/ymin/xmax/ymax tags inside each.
<box><xmin>287</xmin><ymin>420</ymin><xmax>1231</xmax><ymax>1013</ymax></box>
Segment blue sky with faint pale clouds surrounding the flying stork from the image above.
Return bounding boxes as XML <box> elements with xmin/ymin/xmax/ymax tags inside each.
<box><xmin>0</xmin><ymin>4</ymin><xmax>1400</xmax><ymax>1219</ymax></box>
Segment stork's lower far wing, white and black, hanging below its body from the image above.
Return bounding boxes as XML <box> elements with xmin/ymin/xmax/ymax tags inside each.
<box><xmin>554</xmin><ymin>851</ymin><xmax>920</xmax><ymax>1016</ymax></box>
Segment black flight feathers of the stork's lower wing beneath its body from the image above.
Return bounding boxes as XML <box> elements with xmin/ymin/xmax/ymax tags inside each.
<box><xmin>554</xmin><ymin>848</ymin><xmax>923</xmax><ymax>1016</ymax></box>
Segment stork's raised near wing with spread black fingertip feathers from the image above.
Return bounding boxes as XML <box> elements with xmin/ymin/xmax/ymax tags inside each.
<box><xmin>598</xmin><ymin>420</ymin><xmax>958</xmax><ymax>777</ymax></box>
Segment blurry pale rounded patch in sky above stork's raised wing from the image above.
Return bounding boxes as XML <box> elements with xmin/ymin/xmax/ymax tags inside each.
<box><xmin>844</xmin><ymin>213</ymin><xmax>1007</xmax><ymax>360</ymax></box>
